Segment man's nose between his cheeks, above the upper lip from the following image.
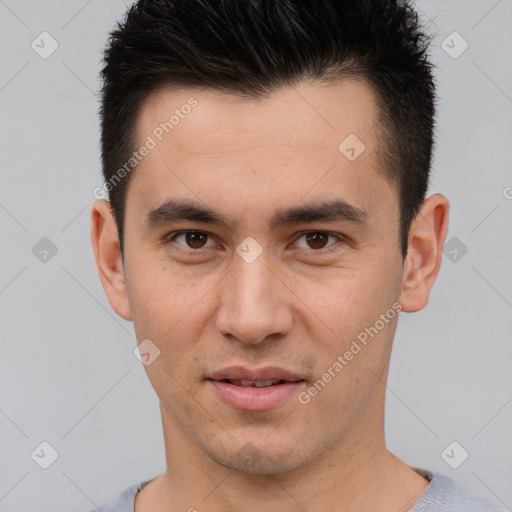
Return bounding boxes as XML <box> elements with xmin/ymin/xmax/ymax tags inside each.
<box><xmin>216</xmin><ymin>250</ymin><xmax>294</xmax><ymax>345</ymax></box>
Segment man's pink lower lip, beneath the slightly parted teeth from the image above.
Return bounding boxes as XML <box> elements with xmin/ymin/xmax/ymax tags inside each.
<box><xmin>207</xmin><ymin>380</ymin><xmax>304</xmax><ymax>411</ymax></box>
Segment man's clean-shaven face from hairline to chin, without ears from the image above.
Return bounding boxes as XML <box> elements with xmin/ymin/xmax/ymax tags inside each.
<box><xmin>120</xmin><ymin>81</ymin><xmax>402</xmax><ymax>473</ymax></box>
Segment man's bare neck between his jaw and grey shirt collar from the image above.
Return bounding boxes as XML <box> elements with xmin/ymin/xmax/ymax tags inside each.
<box><xmin>135</xmin><ymin>390</ymin><xmax>428</xmax><ymax>512</ymax></box>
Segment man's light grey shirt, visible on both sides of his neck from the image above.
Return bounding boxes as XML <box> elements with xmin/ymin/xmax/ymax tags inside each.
<box><xmin>84</xmin><ymin>468</ymin><xmax>505</xmax><ymax>512</ymax></box>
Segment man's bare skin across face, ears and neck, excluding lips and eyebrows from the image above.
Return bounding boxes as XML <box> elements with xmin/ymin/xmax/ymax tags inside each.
<box><xmin>91</xmin><ymin>80</ymin><xmax>449</xmax><ymax>512</ymax></box>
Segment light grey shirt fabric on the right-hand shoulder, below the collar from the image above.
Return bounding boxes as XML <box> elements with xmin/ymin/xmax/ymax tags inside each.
<box><xmin>410</xmin><ymin>473</ymin><xmax>504</xmax><ymax>512</ymax></box>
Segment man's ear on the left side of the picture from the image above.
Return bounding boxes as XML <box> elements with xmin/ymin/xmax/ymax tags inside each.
<box><xmin>91</xmin><ymin>199</ymin><xmax>132</xmax><ymax>320</ymax></box>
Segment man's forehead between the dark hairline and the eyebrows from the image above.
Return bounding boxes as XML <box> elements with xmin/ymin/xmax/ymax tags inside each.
<box><xmin>128</xmin><ymin>80</ymin><xmax>395</xmax><ymax>226</ymax></box>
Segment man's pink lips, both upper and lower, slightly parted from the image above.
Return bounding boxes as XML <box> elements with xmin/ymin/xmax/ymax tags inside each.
<box><xmin>206</xmin><ymin>366</ymin><xmax>305</xmax><ymax>411</ymax></box>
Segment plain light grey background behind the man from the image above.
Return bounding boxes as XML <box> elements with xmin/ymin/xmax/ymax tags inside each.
<box><xmin>0</xmin><ymin>0</ymin><xmax>512</xmax><ymax>512</ymax></box>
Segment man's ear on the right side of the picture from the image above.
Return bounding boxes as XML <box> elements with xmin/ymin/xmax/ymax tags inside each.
<box><xmin>399</xmin><ymin>194</ymin><xmax>450</xmax><ymax>313</ymax></box>
